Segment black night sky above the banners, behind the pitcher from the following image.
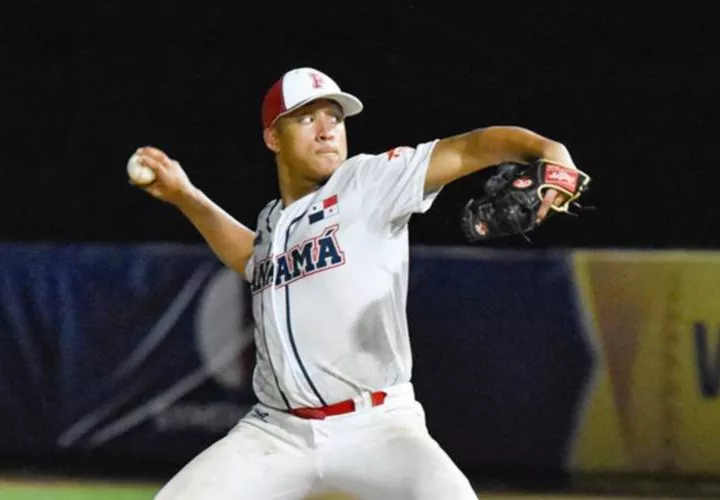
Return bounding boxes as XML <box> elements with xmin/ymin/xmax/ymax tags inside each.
<box><xmin>0</xmin><ymin>1</ymin><xmax>720</xmax><ymax>249</ymax></box>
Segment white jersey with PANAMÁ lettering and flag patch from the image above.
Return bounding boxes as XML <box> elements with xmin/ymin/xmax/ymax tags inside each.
<box><xmin>245</xmin><ymin>140</ymin><xmax>439</xmax><ymax>409</ymax></box>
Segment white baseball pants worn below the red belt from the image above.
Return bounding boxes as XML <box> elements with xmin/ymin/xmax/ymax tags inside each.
<box><xmin>155</xmin><ymin>383</ymin><xmax>478</xmax><ymax>500</ymax></box>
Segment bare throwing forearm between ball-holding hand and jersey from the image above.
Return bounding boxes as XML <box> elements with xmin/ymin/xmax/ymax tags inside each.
<box><xmin>175</xmin><ymin>189</ymin><xmax>255</xmax><ymax>274</ymax></box>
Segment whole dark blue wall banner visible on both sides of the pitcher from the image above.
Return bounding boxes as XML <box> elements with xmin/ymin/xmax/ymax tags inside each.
<box><xmin>0</xmin><ymin>245</ymin><xmax>593</xmax><ymax>471</ymax></box>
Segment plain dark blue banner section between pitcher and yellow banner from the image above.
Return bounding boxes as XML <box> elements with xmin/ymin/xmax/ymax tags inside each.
<box><xmin>408</xmin><ymin>248</ymin><xmax>593</xmax><ymax>472</ymax></box>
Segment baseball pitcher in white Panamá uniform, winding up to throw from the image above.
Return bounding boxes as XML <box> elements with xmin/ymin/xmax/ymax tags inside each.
<box><xmin>132</xmin><ymin>67</ymin><xmax>574</xmax><ymax>500</ymax></box>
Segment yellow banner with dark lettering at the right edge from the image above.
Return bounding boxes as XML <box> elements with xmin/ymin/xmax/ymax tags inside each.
<box><xmin>568</xmin><ymin>251</ymin><xmax>720</xmax><ymax>474</ymax></box>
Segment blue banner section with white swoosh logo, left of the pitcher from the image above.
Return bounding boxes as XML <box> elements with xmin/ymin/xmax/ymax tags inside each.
<box><xmin>0</xmin><ymin>245</ymin><xmax>254</xmax><ymax>459</ymax></box>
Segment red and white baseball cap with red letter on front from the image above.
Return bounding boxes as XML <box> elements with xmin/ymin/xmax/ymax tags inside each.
<box><xmin>262</xmin><ymin>68</ymin><xmax>363</xmax><ymax>128</ymax></box>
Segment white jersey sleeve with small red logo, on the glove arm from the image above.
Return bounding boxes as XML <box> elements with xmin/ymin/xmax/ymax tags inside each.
<box><xmin>356</xmin><ymin>139</ymin><xmax>442</xmax><ymax>224</ymax></box>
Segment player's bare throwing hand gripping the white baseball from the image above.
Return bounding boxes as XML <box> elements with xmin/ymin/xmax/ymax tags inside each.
<box><xmin>130</xmin><ymin>146</ymin><xmax>194</xmax><ymax>204</ymax></box>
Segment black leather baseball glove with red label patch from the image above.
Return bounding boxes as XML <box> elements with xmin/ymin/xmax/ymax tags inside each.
<box><xmin>461</xmin><ymin>160</ymin><xmax>590</xmax><ymax>242</ymax></box>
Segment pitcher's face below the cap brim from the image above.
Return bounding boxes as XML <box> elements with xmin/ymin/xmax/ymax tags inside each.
<box><xmin>275</xmin><ymin>99</ymin><xmax>347</xmax><ymax>182</ymax></box>
